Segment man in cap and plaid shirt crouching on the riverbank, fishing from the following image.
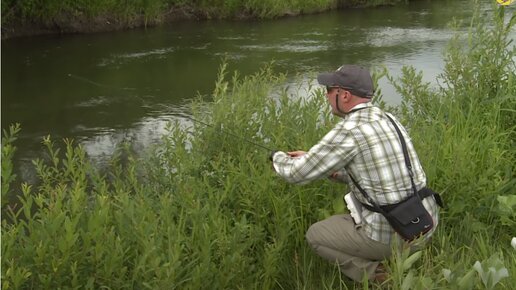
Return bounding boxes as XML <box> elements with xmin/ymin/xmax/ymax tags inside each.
<box><xmin>271</xmin><ymin>65</ymin><xmax>439</xmax><ymax>281</ymax></box>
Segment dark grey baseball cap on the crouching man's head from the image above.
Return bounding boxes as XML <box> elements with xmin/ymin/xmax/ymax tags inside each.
<box><xmin>317</xmin><ymin>64</ymin><xmax>374</xmax><ymax>98</ymax></box>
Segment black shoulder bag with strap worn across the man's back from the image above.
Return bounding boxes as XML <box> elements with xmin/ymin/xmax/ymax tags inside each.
<box><xmin>349</xmin><ymin>115</ymin><xmax>443</xmax><ymax>241</ymax></box>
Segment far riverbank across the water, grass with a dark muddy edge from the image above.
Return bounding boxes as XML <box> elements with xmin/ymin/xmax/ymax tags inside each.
<box><xmin>2</xmin><ymin>0</ymin><xmax>402</xmax><ymax>39</ymax></box>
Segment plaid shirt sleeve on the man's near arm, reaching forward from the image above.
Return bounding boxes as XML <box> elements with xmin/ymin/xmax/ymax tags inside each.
<box><xmin>273</xmin><ymin>125</ymin><xmax>357</xmax><ymax>184</ymax></box>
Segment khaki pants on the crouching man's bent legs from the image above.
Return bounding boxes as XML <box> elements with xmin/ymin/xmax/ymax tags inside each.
<box><xmin>306</xmin><ymin>214</ymin><xmax>391</xmax><ymax>281</ymax></box>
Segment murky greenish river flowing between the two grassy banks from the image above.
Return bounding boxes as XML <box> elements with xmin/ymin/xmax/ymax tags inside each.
<box><xmin>1</xmin><ymin>0</ymin><xmax>508</xmax><ymax>180</ymax></box>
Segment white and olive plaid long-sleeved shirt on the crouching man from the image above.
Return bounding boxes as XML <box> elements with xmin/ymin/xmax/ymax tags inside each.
<box><xmin>273</xmin><ymin>103</ymin><xmax>438</xmax><ymax>244</ymax></box>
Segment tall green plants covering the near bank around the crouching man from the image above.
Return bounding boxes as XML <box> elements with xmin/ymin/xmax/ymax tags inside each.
<box><xmin>1</xmin><ymin>3</ymin><xmax>516</xmax><ymax>289</ymax></box>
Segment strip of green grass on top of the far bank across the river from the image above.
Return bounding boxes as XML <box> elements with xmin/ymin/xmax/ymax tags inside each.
<box><xmin>1</xmin><ymin>0</ymin><xmax>408</xmax><ymax>31</ymax></box>
